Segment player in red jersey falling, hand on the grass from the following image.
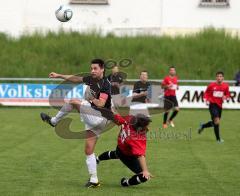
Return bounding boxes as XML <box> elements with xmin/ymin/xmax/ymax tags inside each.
<box><xmin>97</xmin><ymin>114</ymin><xmax>152</xmax><ymax>186</ymax></box>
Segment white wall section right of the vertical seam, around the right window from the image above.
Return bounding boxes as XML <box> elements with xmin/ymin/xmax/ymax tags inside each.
<box><xmin>162</xmin><ymin>0</ymin><xmax>240</xmax><ymax>28</ymax></box>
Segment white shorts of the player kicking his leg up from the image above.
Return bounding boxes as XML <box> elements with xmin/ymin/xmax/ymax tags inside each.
<box><xmin>80</xmin><ymin>100</ymin><xmax>109</xmax><ymax>137</ymax></box>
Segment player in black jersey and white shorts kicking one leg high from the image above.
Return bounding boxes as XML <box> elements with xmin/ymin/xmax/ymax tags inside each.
<box><xmin>41</xmin><ymin>59</ymin><xmax>111</xmax><ymax>187</ymax></box>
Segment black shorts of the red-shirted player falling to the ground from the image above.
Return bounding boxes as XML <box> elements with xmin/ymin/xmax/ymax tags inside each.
<box><xmin>116</xmin><ymin>147</ymin><xmax>142</xmax><ymax>174</ymax></box>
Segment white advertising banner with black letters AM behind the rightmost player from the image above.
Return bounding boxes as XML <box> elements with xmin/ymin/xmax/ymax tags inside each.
<box><xmin>177</xmin><ymin>86</ymin><xmax>240</xmax><ymax>109</ymax></box>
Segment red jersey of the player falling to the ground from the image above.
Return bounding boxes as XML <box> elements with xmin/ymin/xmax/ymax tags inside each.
<box><xmin>114</xmin><ymin>114</ymin><xmax>147</xmax><ymax>156</ymax></box>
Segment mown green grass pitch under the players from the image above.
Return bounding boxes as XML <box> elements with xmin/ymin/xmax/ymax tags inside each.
<box><xmin>0</xmin><ymin>107</ymin><xmax>240</xmax><ymax>196</ymax></box>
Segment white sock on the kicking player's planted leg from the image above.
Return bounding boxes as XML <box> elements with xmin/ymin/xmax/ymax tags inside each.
<box><xmin>86</xmin><ymin>153</ymin><xmax>98</xmax><ymax>183</ymax></box>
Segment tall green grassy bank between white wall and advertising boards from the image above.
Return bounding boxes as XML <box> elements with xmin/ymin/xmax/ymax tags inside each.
<box><xmin>0</xmin><ymin>29</ymin><xmax>240</xmax><ymax>79</ymax></box>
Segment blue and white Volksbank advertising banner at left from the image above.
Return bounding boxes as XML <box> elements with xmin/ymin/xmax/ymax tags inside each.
<box><xmin>0</xmin><ymin>83</ymin><xmax>85</xmax><ymax>106</ymax></box>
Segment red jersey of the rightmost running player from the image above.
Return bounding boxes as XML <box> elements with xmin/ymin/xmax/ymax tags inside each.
<box><xmin>204</xmin><ymin>82</ymin><xmax>230</xmax><ymax>108</ymax></box>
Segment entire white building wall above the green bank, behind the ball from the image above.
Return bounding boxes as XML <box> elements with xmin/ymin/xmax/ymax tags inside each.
<box><xmin>0</xmin><ymin>0</ymin><xmax>240</xmax><ymax>36</ymax></box>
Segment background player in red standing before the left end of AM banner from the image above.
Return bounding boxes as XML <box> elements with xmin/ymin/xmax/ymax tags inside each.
<box><xmin>162</xmin><ymin>66</ymin><xmax>179</xmax><ymax>128</ymax></box>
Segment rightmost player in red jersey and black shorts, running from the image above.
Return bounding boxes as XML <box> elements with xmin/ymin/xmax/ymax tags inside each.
<box><xmin>198</xmin><ymin>72</ymin><xmax>230</xmax><ymax>142</ymax></box>
